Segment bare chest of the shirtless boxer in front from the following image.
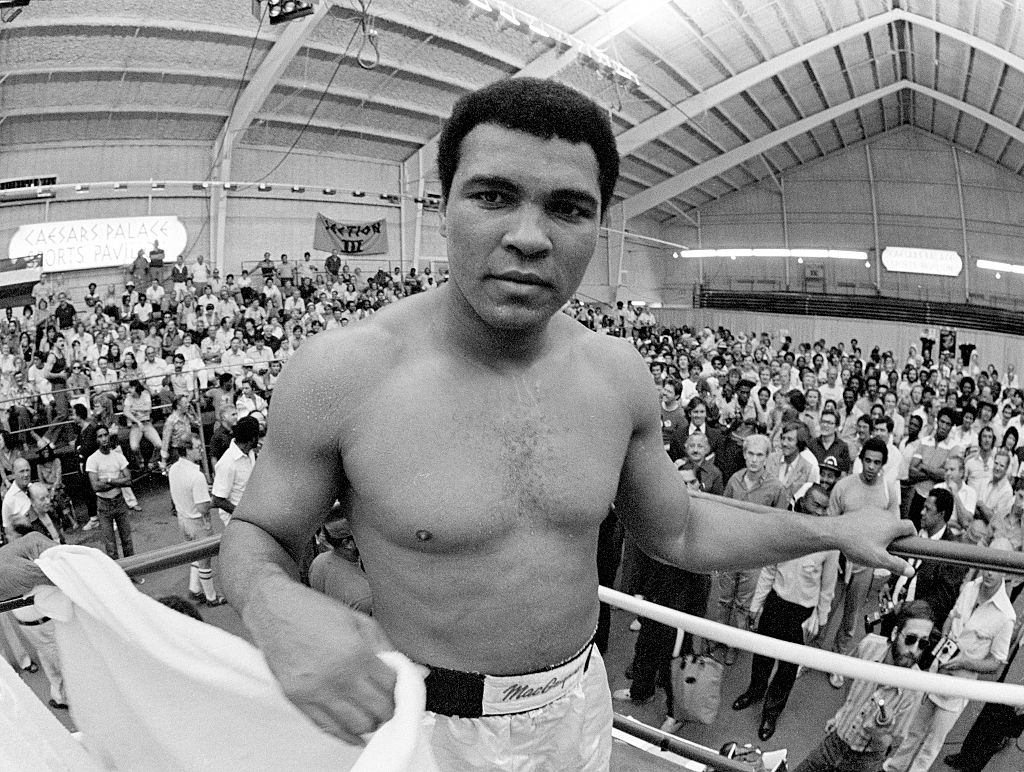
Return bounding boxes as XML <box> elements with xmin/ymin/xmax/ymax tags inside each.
<box><xmin>343</xmin><ymin>371</ymin><xmax>631</xmax><ymax>549</ymax></box>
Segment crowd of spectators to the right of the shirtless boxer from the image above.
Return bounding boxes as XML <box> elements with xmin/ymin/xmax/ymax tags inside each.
<box><xmin>564</xmin><ymin>300</ymin><xmax>1024</xmax><ymax>772</ymax></box>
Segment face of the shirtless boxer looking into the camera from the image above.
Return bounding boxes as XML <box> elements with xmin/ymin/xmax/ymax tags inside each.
<box><xmin>441</xmin><ymin>124</ymin><xmax>600</xmax><ymax>330</ymax></box>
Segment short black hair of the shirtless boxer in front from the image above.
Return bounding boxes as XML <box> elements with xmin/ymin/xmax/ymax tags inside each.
<box><xmin>437</xmin><ymin>78</ymin><xmax>618</xmax><ymax>216</ymax></box>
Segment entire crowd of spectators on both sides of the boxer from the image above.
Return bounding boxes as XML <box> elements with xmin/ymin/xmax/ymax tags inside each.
<box><xmin>0</xmin><ymin>264</ymin><xmax>1024</xmax><ymax>765</ymax></box>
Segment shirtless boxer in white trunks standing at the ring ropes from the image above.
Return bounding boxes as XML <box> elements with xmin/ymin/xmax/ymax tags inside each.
<box><xmin>221</xmin><ymin>78</ymin><xmax>912</xmax><ymax>770</ymax></box>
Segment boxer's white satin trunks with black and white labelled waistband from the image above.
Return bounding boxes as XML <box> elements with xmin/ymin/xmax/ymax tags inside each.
<box><xmin>420</xmin><ymin>643</ymin><xmax>611</xmax><ymax>772</ymax></box>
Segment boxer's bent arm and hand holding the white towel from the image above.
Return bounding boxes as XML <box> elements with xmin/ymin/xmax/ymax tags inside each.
<box><xmin>220</xmin><ymin>333</ymin><xmax>395</xmax><ymax>743</ymax></box>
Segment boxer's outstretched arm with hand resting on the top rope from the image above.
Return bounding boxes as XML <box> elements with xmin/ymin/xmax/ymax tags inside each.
<box><xmin>611</xmin><ymin>342</ymin><xmax>913</xmax><ymax>573</ymax></box>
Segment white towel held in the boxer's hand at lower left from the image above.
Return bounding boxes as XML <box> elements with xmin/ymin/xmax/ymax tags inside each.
<box><xmin>29</xmin><ymin>546</ymin><xmax>425</xmax><ymax>772</ymax></box>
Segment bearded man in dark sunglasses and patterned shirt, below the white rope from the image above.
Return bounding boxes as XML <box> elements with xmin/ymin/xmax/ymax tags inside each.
<box><xmin>795</xmin><ymin>600</ymin><xmax>934</xmax><ymax>772</ymax></box>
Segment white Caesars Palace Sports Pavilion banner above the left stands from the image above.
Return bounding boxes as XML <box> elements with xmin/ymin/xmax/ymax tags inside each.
<box><xmin>7</xmin><ymin>215</ymin><xmax>188</xmax><ymax>273</ymax></box>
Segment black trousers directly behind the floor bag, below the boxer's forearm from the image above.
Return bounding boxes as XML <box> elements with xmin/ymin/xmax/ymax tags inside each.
<box><xmin>630</xmin><ymin>560</ymin><xmax>711</xmax><ymax>715</ymax></box>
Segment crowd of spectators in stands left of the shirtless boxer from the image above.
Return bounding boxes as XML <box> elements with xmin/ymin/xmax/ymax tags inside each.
<box><xmin>0</xmin><ymin>251</ymin><xmax>443</xmax><ymax>541</ymax></box>
